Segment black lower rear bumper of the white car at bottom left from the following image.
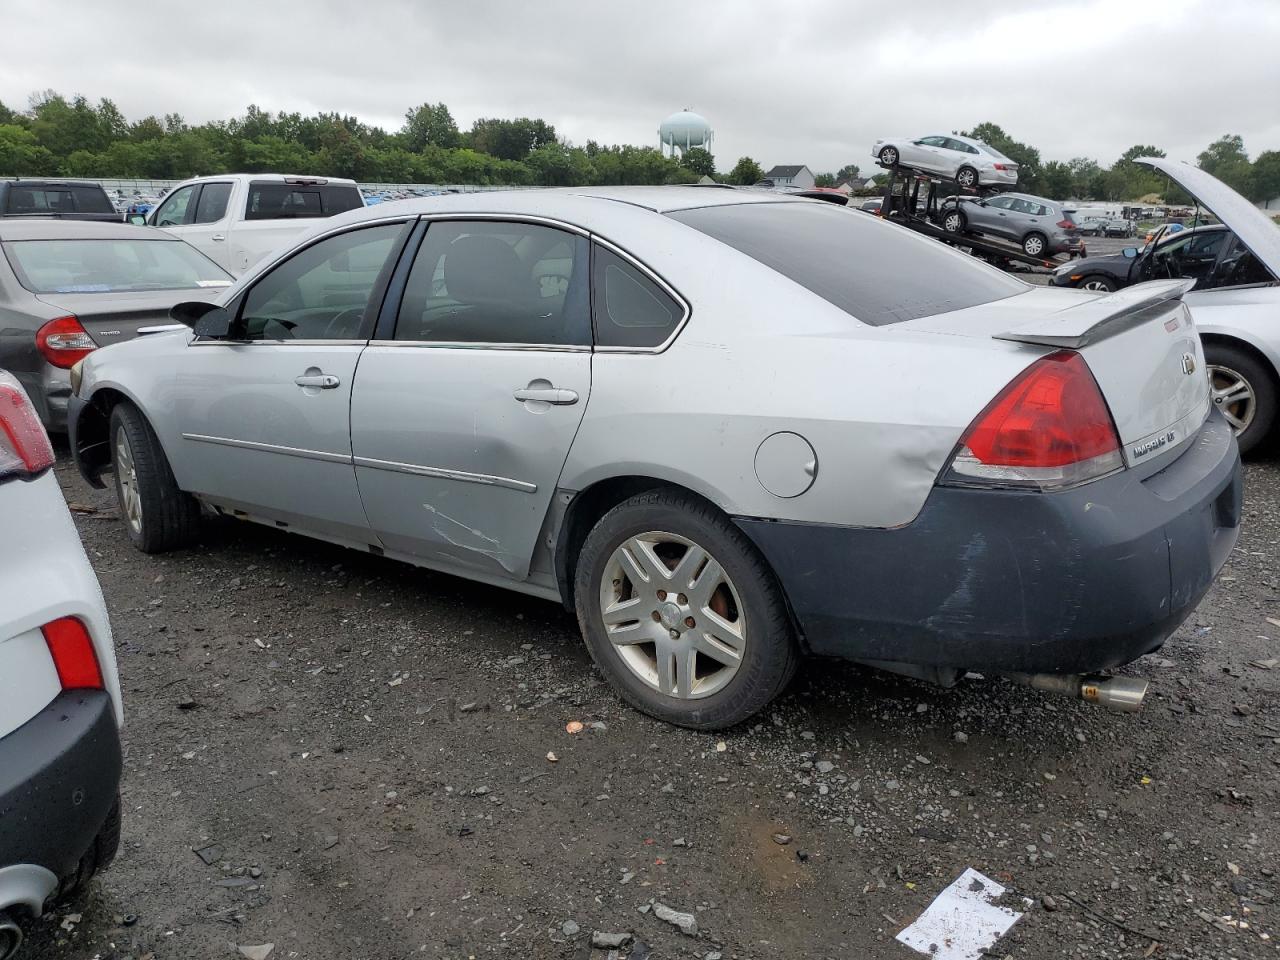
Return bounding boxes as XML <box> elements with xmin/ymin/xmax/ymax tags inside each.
<box><xmin>0</xmin><ymin>690</ymin><xmax>120</xmax><ymax>908</ymax></box>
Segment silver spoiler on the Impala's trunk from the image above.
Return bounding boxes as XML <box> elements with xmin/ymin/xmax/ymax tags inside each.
<box><xmin>995</xmin><ymin>280</ymin><xmax>1196</xmax><ymax>349</ymax></box>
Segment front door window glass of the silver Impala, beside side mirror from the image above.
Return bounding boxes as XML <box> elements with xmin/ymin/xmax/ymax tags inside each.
<box><xmin>236</xmin><ymin>223</ymin><xmax>404</xmax><ymax>340</ymax></box>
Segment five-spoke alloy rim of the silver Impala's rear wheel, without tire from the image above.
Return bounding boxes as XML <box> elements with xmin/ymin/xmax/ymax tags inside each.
<box><xmin>599</xmin><ymin>531</ymin><xmax>748</xmax><ymax>700</ymax></box>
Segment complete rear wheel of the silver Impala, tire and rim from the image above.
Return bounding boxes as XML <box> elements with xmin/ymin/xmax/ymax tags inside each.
<box><xmin>575</xmin><ymin>490</ymin><xmax>799</xmax><ymax>730</ymax></box>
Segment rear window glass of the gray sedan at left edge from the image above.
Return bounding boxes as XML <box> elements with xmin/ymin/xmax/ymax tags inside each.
<box><xmin>0</xmin><ymin>239</ymin><xmax>232</xmax><ymax>293</ymax></box>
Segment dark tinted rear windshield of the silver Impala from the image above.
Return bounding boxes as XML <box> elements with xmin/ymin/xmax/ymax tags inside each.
<box><xmin>671</xmin><ymin>204</ymin><xmax>1029</xmax><ymax>326</ymax></box>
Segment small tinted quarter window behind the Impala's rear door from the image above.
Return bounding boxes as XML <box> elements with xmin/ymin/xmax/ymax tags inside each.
<box><xmin>591</xmin><ymin>246</ymin><xmax>685</xmax><ymax>347</ymax></box>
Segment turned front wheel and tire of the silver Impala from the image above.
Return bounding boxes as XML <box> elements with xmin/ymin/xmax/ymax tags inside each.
<box><xmin>108</xmin><ymin>402</ymin><xmax>200</xmax><ymax>553</ymax></box>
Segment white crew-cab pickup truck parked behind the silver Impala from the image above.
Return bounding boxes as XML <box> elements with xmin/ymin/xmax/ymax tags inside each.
<box><xmin>145</xmin><ymin>173</ymin><xmax>365</xmax><ymax>276</ymax></box>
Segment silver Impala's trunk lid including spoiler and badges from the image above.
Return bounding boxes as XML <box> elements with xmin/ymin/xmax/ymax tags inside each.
<box><xmin>901</xmin><ymin>280</ymin><xmax>1210</xmax><ymax>466</ymax></box>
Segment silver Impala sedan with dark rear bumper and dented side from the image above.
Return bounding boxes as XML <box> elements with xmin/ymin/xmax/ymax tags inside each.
<box><xmin>70</xmin><ymin>187</ymin><xmax>1240</xmax><ymax>728</ymax></box>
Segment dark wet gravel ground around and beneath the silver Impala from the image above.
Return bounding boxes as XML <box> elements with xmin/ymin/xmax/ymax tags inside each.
<box><xmin>12</xmin><ymin>458</ymin><xmax>1280</xmax><ymax>960</ymax></box>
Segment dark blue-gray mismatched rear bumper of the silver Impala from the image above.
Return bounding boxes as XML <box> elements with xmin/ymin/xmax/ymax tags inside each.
<box><xmin>737</xmin><ymin>413</ymin><xmax>1242</xmax><ymax>673</ymax></box>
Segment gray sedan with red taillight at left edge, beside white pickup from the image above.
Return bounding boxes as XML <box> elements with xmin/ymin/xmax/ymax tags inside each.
<box><xmin>0</xmin><ymin>220</ymin><xmax>232</xmax><ymax>433</ymax></box>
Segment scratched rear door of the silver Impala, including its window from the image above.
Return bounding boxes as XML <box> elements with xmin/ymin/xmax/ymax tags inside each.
<box><xmin>351</xmin><ymin>219</ymin><xmax>591</xmax><ymax>581</ymax></box>
